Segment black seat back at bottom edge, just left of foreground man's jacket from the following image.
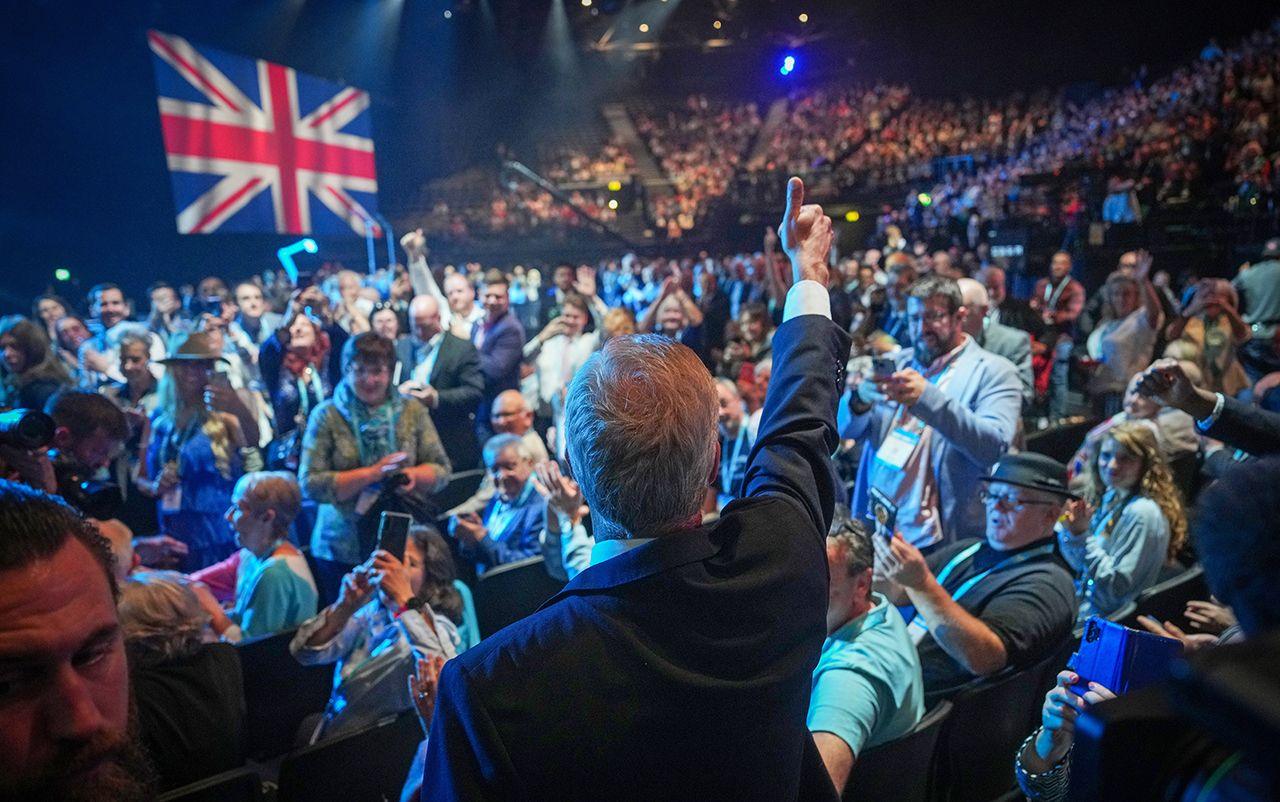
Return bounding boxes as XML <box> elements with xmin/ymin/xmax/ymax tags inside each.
<box><xmin>276</xmin><ymin>711</ymin><xmax>422</xmax><ymax>802</ymax></box>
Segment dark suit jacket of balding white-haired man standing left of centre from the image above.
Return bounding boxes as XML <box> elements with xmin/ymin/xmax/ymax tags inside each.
<box><xmin>396</xmin><ymin>333</ymin><xmax>484</xmax><ymax>471</ymax></box>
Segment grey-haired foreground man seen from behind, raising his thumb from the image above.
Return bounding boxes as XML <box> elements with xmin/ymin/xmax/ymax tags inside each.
<box><xmin>422</xmin><ymin>178</ymin><xmax>850</xmax><ymax>799</ymax></box>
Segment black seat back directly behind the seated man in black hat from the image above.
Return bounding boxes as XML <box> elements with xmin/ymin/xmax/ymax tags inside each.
<box><xmin>931</xmin><ymin>650</ymin><xmax>1065</xmax><ymax>802</ymax></box>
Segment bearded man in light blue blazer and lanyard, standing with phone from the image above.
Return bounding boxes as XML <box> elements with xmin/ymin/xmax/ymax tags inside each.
<box><xmin>842</xmin><ymin>275</ymin><xmax>1023</xmax><ymax>550</ymax></box>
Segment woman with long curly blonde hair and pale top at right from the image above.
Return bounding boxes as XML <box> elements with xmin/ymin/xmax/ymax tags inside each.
<box><xmin>1057</xmin><ymin>421</ymin><xmax>1187</xmax><ymax>620</ymax></box>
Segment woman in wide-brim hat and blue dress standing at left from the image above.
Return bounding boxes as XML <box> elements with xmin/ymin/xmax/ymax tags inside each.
<box><xmin>138</xmin><ymin>333</ymin><xmax>246</xmax><ymax>572</ymax></box>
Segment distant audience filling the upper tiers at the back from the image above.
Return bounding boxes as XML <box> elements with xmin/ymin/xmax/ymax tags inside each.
<box><xmin>409</xmin><ymin>26</ymin><xmax>1280</xmax><ymax>249</ymax></box>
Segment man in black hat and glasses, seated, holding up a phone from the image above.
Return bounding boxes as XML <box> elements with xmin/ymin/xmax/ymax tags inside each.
<box><xmin>876</xmin><ymin>453</ymin><xmax>1075</xmax><ymax>704</ymax></box>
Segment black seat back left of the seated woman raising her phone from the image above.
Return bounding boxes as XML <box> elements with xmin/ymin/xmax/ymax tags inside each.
<box><xmin>237</xmin><ymin>629</ymin><xmax>333</xmax><ymax>760</ymax></box>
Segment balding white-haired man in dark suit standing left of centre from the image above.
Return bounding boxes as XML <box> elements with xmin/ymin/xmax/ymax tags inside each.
<box><xmin>396</xmin><ymin>295</ymin><xmax>484</xmax><ymax>471</ymax></box>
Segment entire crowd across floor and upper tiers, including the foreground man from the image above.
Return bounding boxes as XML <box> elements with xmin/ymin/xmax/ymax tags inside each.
<box><xmin>0</xmin><ymin>23</ymin><xmax>1280</xmax><ymax>799</ymax></box>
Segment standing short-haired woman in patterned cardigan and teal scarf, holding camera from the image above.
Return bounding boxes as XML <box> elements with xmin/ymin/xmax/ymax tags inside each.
<box><xmin>298</xmin><ymin>331</ymin><xmax>449</xmax><ymax>599</ymax></box>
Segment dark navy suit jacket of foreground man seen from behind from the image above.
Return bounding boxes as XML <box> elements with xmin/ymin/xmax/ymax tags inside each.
<box><xmin>422</xmin><ymin>316</ymin><xmax>849</xmax><ymax>801</ymax></box>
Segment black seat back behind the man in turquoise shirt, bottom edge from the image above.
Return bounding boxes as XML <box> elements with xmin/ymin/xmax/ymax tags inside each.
<box><xmin>841</xmin><ymin>701</ymin><xmax>952</xmax><ymax>802</ymax></box>
